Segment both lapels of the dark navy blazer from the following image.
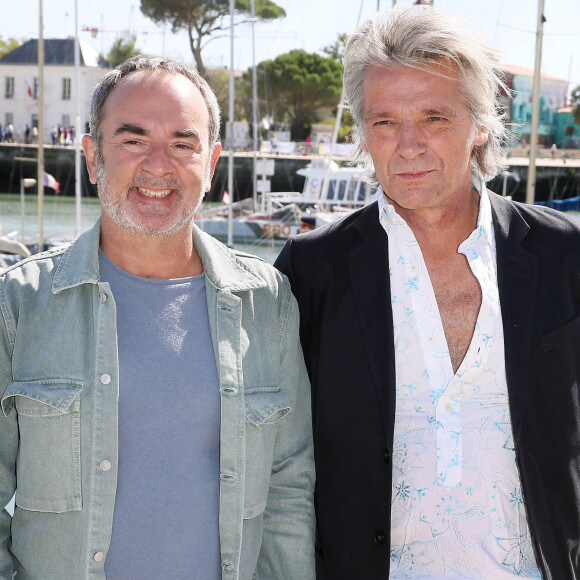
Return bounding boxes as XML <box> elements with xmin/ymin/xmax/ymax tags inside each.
<box><xmin>340</xmin><ymin>192</ymin><xmax>538</xmax><ymax>441</ymax></box>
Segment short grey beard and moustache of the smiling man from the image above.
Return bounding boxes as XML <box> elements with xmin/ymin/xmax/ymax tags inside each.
<box><xmin>97</xmin><ymin>159</ymin><xmax>209</xmax><ymax>237</ymax></box>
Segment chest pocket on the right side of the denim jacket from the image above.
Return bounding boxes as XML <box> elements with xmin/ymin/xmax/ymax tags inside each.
<box><xmin>244</xmin><ymin>386</ymin><xmax>291</xmax><ymax>519</ymax></box>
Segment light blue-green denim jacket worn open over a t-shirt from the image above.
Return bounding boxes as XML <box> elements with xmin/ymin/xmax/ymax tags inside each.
<box><xmin>0</xmin><ymin>222</ymin><xmax>314</xmax><ymax>580</ymax></box>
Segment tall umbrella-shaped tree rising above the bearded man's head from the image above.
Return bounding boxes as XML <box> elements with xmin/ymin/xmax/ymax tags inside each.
<box><xmin>141</xmin><ymin>0</ymin><xmax>286</xmax><ymax>75</ymax></box>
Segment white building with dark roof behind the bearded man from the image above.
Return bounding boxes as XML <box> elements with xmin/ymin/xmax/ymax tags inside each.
<box><xmin>0</xmin><ymin>38</ymin><xmax>111</xmax><ymax>143</ymax></box>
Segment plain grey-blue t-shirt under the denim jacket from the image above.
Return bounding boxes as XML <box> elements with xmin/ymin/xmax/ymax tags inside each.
<box><xmin>100</xmin><ymin>253</ymin><xmax>221</xmax><ymax>580</ymax></box>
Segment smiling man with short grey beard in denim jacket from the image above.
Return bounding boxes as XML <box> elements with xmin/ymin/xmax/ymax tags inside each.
<box><xmin>0</xmin><ymin>55</ymin><xmax>314</xmax><ymax>580</ymax></box>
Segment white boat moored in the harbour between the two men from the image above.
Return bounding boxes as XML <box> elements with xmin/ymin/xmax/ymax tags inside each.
<box><xmin>197</xmin><ymin>158</ymin><xmax>376</xmax><ymax>243</ymax></box>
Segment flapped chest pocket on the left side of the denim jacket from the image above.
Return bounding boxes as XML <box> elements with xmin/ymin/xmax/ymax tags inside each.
<box><xmin>1</xmin><ymin>379</ymin><xmax>83</xmax><ymax>513</ymax></box>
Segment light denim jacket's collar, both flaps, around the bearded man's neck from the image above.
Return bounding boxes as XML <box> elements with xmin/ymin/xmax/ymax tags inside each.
<box><xmin>52</xmin><ymin>218</ymin><xmax>267</xmax><ymax>294</ymax></box>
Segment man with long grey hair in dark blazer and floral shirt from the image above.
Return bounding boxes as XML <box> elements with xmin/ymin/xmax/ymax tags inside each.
<box><xmin>276</xmin><ymin>6</ymin><xmax>580</xmax><ymax>580</ymax></box>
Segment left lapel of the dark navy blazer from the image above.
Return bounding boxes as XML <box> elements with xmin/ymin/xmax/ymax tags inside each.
<box><xmin>347</xmin><ymin>204</ymin><xmax>395</xmax><ymax>441</ymax></box>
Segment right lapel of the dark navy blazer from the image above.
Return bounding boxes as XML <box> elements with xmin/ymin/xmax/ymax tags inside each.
<box><xmin>490</xmin><ymin>193</ymin><xmax>538</xmax><ymax>439</ymax></box>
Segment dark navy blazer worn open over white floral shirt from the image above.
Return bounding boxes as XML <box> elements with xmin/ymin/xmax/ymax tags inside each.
<box><xmin>276</xmin><ymin>193</ymin><xmax>580</xmax><ymax>580</ymax></box>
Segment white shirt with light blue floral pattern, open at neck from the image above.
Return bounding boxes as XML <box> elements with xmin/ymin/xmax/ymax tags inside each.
<box><xmin>378</xmin><ymin>175</ymin><xmax>541</xmax><ymax>580</ymax></box>
